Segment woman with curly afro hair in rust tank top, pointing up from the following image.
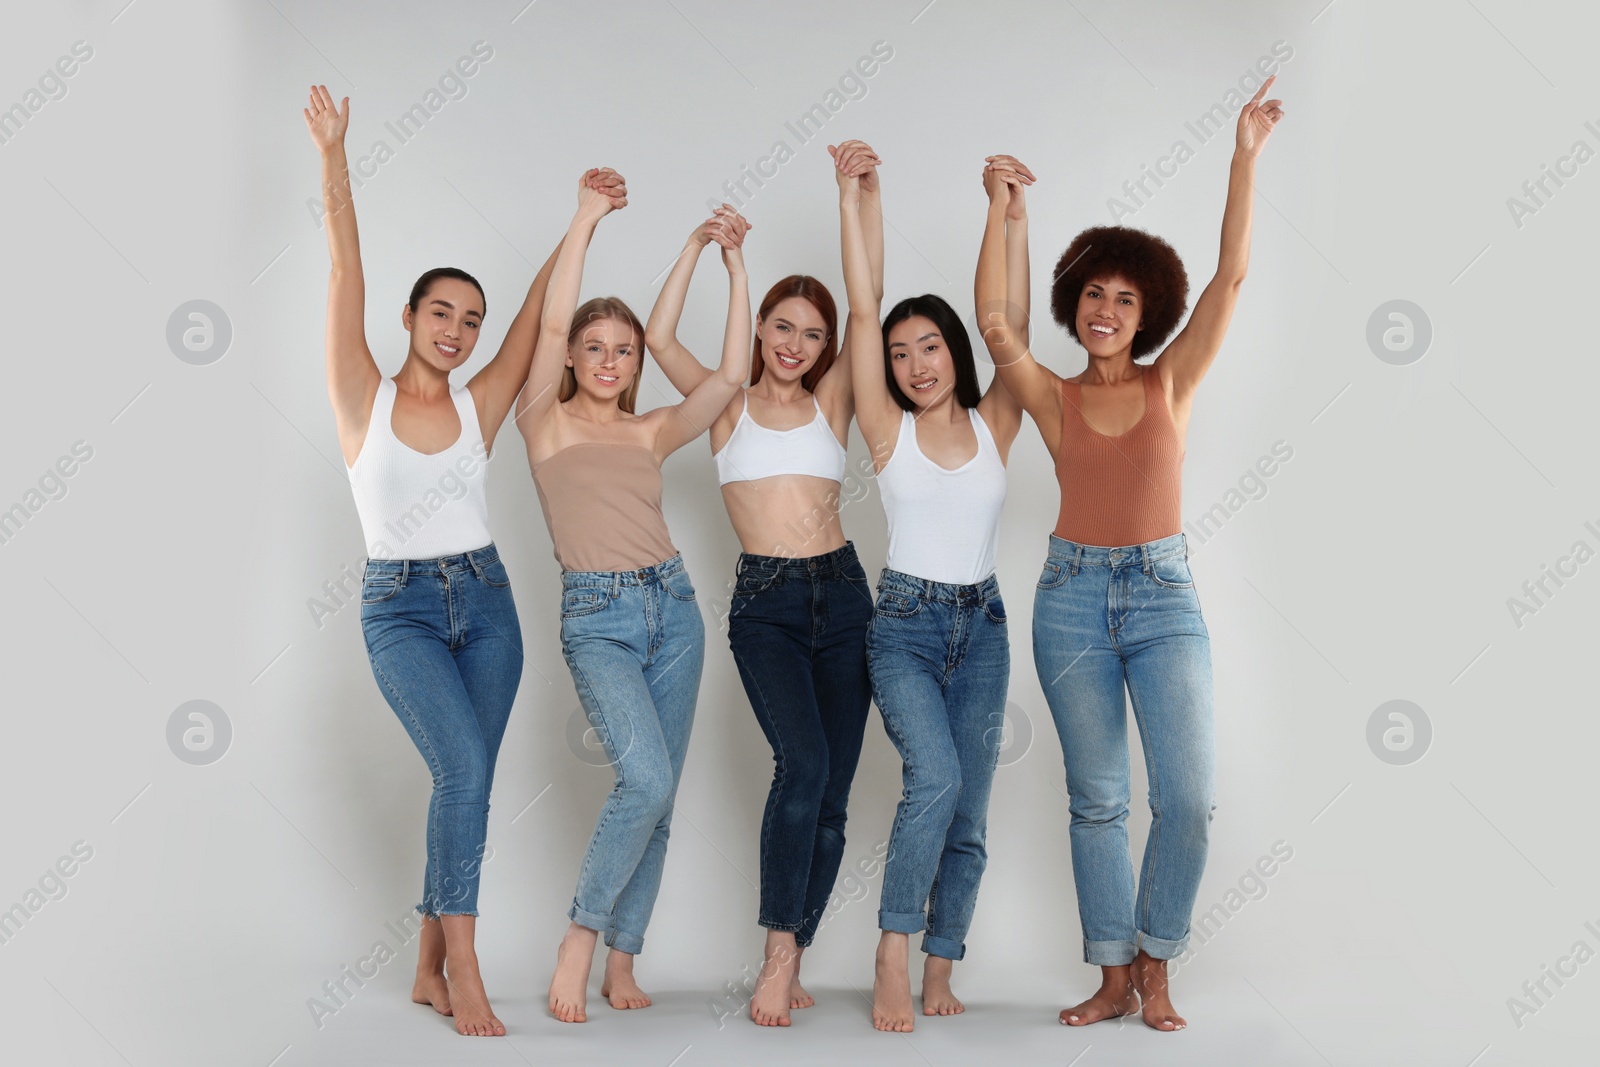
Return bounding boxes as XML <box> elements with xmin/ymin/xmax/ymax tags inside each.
<box><xmin>978</xmin><ymin>78</ymin><xmax>1283</xmax><ymax>1030</ymax></box>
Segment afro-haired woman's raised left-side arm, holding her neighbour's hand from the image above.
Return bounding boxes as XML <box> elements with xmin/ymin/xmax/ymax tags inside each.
<box><xmin>973</xmin><ymin>155</ymin><xmax>1061</xmax><ymax>451</ymax></box>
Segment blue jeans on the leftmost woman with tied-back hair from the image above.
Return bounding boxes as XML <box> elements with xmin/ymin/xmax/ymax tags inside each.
<box><xmin>362</xmin><ymin>544</ymin><xmax>522</xmax><ymax>917</ymax></box>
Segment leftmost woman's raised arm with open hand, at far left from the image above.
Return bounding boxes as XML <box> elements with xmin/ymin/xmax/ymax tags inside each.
<box><xmin>301</xmin><ymin>85</ymin><xmax>382</xmax><ymax>464</ymax></box>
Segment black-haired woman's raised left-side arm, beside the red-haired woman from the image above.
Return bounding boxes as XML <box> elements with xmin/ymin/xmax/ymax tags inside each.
<box><xmin>835</xmin><ymin>168</ymin><xmax>901</xmax><ymax>470</ymax></box>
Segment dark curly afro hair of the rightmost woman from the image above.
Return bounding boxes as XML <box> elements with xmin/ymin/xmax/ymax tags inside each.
<box><xmin>1050</xmin><ymin>226</ymin><xmax>1189</xmax><ymax>360</ymax></box>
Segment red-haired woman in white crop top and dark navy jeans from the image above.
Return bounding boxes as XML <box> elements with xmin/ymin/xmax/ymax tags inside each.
<box><xmin>645</xmin><ymin>141</ymin><xmax>883</xmax><ymax>1025</ymax></box>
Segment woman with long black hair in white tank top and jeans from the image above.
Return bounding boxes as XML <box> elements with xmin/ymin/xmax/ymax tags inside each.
<box><xmin>838</xmin><ymin>154</ymin><xmax>1027</xmax><ymax>1033</ymax></box>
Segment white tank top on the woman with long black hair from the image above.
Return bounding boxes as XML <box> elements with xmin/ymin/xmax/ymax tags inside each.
<box><xmin>878</xmin><ymin>408</ymin><xmax>1005</xmax><ymax>585</ymax></box>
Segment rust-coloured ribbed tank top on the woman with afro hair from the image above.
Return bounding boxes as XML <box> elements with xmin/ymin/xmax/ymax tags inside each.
<box><xmin>1056</xmin><ymin>366</ymin><xmax>1184</xmax><ymax>549</ymax></box>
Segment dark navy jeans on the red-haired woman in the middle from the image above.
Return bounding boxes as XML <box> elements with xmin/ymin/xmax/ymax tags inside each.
<box><xmin>728</xmin><ymin>542</ymin><xmax>872</xmax><ymax>945</ymax></box>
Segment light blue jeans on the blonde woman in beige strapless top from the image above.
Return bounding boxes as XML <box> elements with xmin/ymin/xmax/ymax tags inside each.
<box><xmin>562</xmin><ymin>555</ymin><xmax>706</xmax><ymax>955</ymax></box>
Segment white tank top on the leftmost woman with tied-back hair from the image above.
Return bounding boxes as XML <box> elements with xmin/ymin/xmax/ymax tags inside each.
<box><xmin>346</xmin><ymin>378</ymin><xmax>491</xmax><ymax>560</ymax></box>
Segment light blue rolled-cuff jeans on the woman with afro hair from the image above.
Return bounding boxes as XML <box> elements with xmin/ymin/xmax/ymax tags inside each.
<box><xmin>1034</xmin><ymin>533</ymin><xmax>1216</xmax><ymax>966</ymax></box>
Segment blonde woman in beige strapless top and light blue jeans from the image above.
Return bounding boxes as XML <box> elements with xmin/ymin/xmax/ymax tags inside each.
<box><xmin>517</xmin><ymin>182</ymin><xmax>750</xmax><ymax>1022</ymax></box>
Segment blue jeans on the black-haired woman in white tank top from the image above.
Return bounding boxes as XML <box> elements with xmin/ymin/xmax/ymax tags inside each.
<box><xmin>867</xmin><ymin>568</ymin><xmax>1011</xmax><ymax>960</ymax></box>
